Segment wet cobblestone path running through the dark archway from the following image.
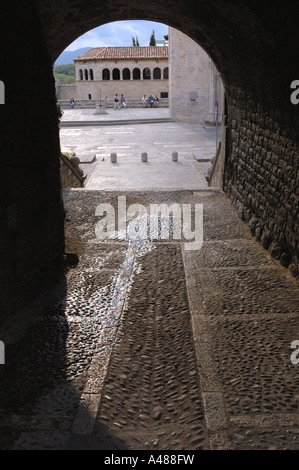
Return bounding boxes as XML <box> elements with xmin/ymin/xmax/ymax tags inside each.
<box><xmin>0</xmin><ymin>190</ymin><xmax>299</xmax><ymax>450</ymax></box>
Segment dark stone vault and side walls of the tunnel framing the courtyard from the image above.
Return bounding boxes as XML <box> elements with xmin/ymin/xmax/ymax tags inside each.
<box><xmin>0</xmin><ymin>0</ymin><xmax>299</xmax><ymax>313</ymax></box>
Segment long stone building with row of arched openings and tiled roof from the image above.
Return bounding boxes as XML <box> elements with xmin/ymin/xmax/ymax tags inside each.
<box><xmin>71</xmin><ymin>46</ymin><xmax>169</xmax><ymax>100</ymax></box>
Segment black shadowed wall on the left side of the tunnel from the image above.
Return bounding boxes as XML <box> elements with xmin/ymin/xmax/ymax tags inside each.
<box><xmin>0</xmin><ymin>0</ymin><xmax>64</xmax><ymax>318</ymax></box>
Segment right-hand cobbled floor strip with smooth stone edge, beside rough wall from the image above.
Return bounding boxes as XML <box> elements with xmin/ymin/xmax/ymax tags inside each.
<box><xmin>184</xmin><ymin>194</ymin><xmax>299</xmax><ymax>450</ymax></box>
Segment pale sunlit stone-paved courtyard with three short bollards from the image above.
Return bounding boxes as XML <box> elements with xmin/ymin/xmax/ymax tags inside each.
<box><xmin>60</xmin><ymin>121</ymin><xmax>216</xmax><ymax>191</ymax></box>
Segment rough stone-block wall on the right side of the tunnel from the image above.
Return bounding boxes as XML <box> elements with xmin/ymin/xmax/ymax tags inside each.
<box><xmin>224</xmin><ymin>93</ymin><xmax>299</xmax><ymax>277</ymax></box>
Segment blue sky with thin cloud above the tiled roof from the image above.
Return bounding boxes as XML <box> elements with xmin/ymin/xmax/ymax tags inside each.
<box><xmin>66</xmin><ymin>20</ymin><xmax>168</xmax><ymax>51</ymax></box>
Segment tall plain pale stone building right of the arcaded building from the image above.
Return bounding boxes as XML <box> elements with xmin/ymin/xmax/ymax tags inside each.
<box><xmin>169</xmin><ymin>28</ymin><xmax>223</xmax><ymax>122</ymax></box>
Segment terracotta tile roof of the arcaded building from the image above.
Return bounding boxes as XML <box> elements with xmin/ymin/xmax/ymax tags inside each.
<box><xmin>74</xmin><ymin>46</ymin><xmax>168</xmax><ymax>61</ymax></box>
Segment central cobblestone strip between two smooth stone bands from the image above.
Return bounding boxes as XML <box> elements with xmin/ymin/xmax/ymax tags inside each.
<box><xmin>92</xmin><ymin>245</ymin><xmax>208</xmax><ymax>450</ymax></box>
